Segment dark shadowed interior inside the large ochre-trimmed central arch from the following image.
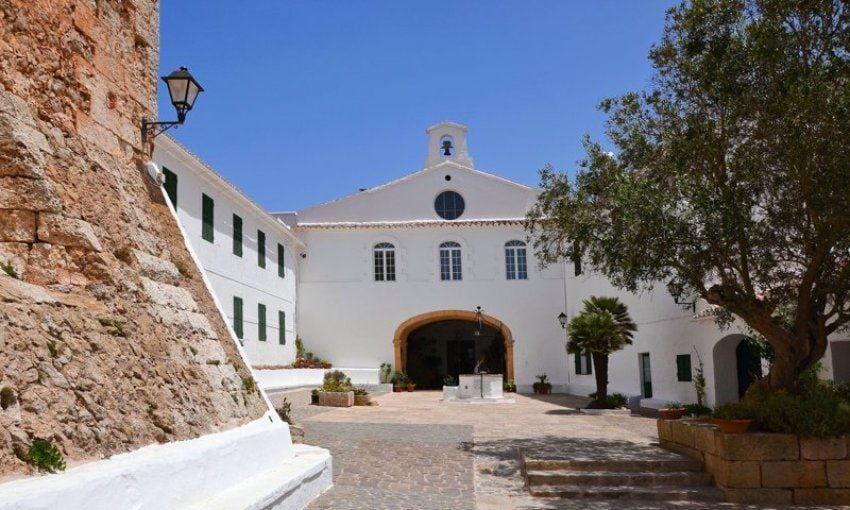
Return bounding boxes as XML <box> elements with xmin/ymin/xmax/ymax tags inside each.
<box><xmin>405</xmin><ymin>320</ymin><xmax>507</xmax><ymax>389</ymax></box>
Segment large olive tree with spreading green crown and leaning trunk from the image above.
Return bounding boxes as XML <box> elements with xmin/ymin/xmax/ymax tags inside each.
<box><xmin>527</xmin><ymin>0</ymin><xmax>850</xmax><ymax>389</ymax></box>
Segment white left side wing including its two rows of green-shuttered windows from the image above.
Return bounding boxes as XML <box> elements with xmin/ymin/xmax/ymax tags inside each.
<box><xmin>153</xmin><ymin>135</ymin><xmax>305</xmax><ymax>366</ymax></box>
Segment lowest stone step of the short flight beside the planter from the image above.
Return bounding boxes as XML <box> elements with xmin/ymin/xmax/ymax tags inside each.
<box><xmin>529</xmin><ymin>485</ymin><xmax>723</xmax><ymax>502</ymax></box>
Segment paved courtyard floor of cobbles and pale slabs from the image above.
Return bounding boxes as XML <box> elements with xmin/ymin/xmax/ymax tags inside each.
<box><xmin>272</xmin><ymin>391</ymin><xmax>836</xmax><ymax>510</ymax></box>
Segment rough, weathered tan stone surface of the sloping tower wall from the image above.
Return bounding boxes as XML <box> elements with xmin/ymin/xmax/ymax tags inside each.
<box><xmin>0</xmin><ymin>0</ymin><xmax>266</xmax><ymax>478</ymax></box>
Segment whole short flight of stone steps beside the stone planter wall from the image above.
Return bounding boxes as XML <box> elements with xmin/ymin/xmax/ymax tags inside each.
<box><xmin>522</xmin><ymin>445</ymin><xmax>723</xmax><ymax>503</ymax></box>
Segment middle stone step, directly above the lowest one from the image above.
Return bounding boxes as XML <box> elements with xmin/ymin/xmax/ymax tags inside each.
<box><xmin>526</xmin><ymin>470</ymin><xmax>713</xmax><ymax>487</ymax></box>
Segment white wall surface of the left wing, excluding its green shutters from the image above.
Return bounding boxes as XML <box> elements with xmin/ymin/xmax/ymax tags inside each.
<box><xmin>154</xmin><ymin>137</ymin><xmax>303</xmax><ymax>365</ymax></box>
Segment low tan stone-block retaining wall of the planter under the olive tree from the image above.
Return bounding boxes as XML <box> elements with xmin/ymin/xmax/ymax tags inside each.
<box><xmin>658</xmin><ymin>420</ymin><xmax>850</xmax><ymax>505</ymax></box>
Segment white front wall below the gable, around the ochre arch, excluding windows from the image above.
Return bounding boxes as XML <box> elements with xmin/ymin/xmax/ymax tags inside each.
<box><xmin>299</xmin><ymin>225</ymin><xmax>567</xmax><ymax>386</ymax></box>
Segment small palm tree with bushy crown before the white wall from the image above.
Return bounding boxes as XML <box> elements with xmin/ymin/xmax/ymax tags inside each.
<box><xmin>567</xmin><ymin>296</ymin><xmax>637</xmax><ymax>405</ymax></box>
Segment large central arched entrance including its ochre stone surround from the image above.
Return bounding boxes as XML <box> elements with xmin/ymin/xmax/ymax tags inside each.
<box><xmin>393</xmin><ymin>310</ymin><xmax>514</xmax><ymax>387</ymax></box>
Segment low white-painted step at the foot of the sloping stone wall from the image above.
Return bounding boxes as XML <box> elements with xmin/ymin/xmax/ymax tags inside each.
<box><xmin>187</xmin><ymin>444</ymin><xmax>333</xmax><ymax>510</ymax></box>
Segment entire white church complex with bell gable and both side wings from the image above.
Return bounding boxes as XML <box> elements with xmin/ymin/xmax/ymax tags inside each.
<box><xmin>155</xmin><ymin>122</ymin><xmax>850</xmax><ymax>407</ymax></box>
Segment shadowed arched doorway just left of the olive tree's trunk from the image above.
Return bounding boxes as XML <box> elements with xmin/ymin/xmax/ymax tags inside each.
<box><xmin>713</xmin><ymin>335</ymin><xmax>763</xmax><ymax>405</ymax></box>
